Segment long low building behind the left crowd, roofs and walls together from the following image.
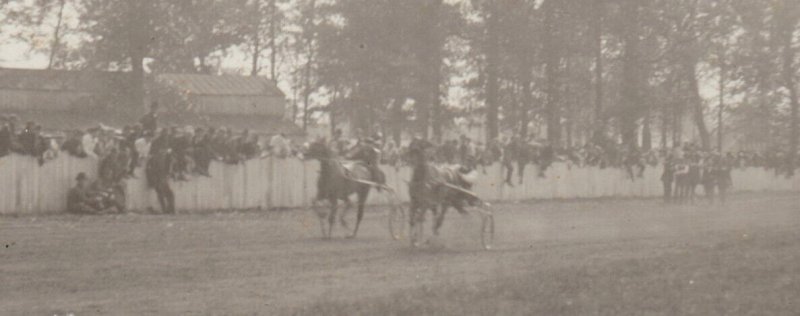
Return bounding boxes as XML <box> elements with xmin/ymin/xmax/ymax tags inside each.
<box><xmin>0</xmin><ymin>68</ymin><xmax>302</xmax><ymax>137</ymax></box>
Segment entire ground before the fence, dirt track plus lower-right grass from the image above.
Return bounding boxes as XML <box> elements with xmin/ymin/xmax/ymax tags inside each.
<box><xmin>0</xmin><ymin>194</ymin><xmax>800</xmax><ymax>315</ymax></box>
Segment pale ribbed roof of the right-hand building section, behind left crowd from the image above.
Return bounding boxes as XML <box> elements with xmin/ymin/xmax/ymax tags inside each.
<box><xmin>156</xmin><ymin>74</ymin><xmax>284</xmax><ymax>98</ymax></box>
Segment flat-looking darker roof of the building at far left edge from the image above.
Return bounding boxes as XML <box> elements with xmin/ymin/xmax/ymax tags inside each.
<box><xmin>0</xmin><ymin>67</ymin><xmax>130</xmax><ymax>93</ymax></box>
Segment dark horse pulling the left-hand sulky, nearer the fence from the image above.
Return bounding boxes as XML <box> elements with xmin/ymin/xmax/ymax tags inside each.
<box><xmin>305</xmin><ymin>140</ymin><xmax>372</xmax><ymax>238</ymax></box>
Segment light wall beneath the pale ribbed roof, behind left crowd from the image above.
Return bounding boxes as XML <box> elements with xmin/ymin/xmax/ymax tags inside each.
<box><xmin>191</xmin><ymin>96</ymin><xmax>286</xmax><ymax>117</ymax></box>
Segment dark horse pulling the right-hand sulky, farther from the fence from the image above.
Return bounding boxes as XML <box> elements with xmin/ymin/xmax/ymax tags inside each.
<box><xmin>406</xmin><ymin>139</ymin><xmax>474</xmax><ymax>246</ymax></box>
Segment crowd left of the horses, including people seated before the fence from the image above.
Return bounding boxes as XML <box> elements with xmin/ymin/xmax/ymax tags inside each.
<box><xmin>0</xmin><ymin>103</ymin><xmax>300</xmax><ymax>213</ymax></box>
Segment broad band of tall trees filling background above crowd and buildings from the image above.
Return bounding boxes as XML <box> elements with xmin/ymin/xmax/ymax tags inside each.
<box><xmin>0</xmin><ymin>0</ymin><xmax>800</xmax><ymax>160</ymax></box>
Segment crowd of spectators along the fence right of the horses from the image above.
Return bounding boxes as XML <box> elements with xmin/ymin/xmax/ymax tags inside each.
<box><xmin>368</xmin><ymin>136</ymin><xmax>800</xmax><ymax>184</ymax></box>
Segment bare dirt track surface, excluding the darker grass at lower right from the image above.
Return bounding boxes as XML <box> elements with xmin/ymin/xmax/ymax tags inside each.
<box><xmin>0</xmin><ymin>194</ymin><xmax>800</xmax><ymax>315</ymax></box>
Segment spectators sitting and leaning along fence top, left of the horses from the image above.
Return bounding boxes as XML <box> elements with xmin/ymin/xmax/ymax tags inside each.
<box><xmin>0</xmin><ymin>111</ymin><xmax>299</xmax><ymax>181</ymax></box>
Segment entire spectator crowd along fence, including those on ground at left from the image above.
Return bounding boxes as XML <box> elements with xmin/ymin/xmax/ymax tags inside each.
<box><xmin>0</xmin><ymin>111</ymin><xmax>800</xmax><ymax>212</ymax></box>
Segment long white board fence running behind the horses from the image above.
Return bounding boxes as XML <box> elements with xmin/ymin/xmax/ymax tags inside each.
<box><xmin>0</xmin><ymin>155</ymin><xmax>800</xmax><ymax>214</ymax></box>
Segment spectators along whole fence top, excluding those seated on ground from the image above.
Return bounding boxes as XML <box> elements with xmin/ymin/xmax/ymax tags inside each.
<box><xmin>0</xmin><ymin>109</ymin><xmax>800</xmax><ymax>183</ymax></box>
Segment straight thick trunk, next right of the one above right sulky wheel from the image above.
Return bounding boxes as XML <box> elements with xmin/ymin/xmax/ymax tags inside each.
<box><xmin>542</xmin><ymin>0</ymin><xmax>561</xmax><ymax>145</ymax></box>
